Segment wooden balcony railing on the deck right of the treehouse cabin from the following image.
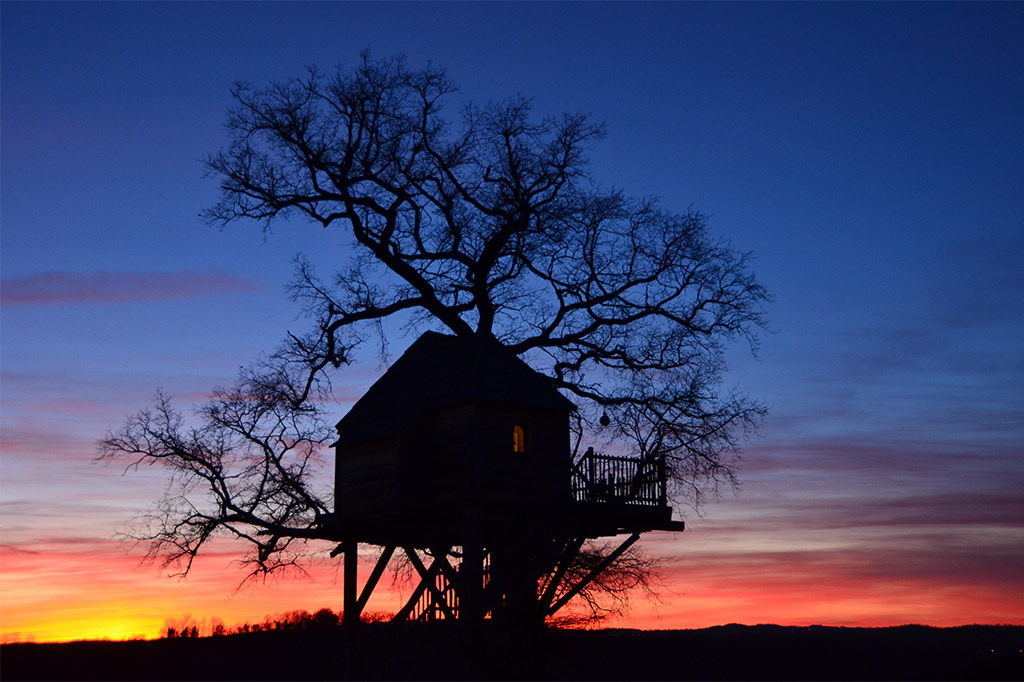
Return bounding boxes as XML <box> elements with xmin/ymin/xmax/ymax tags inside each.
<box><xmin>572</xmin><ymin>451</ymin><xmax>669</xmax><ymax>507</ymax></box>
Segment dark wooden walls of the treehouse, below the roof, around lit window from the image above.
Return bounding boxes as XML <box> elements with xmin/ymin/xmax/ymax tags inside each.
<box><xmin>336</xmin><ymin>401</ymin><xmax>570</xmax><ymax>522</ymax></box>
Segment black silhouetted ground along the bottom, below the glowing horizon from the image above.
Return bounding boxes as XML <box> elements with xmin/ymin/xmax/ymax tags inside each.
<box><xmin>0</xmin><ymin>624</ymin><xmax>1024</xmax><ymax>682</ymax></box>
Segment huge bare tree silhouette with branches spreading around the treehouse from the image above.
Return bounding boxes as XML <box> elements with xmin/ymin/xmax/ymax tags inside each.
<box><xmin>99</xmin><ymin>54</ymin><xmax>768</xmax><ymax>614</ymax></box>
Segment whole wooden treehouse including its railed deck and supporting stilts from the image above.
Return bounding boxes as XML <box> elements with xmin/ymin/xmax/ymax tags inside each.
<box><xmin>325</xmin><ymin>332</ymin><xmax>683</xmax><ymax>623</ymax></box>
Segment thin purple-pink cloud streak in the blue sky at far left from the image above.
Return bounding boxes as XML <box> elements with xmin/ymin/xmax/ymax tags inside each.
<box><xmin>0</xmin><ymin>269</ymin><xmax>258</xmax><ymax>305</ymax></box>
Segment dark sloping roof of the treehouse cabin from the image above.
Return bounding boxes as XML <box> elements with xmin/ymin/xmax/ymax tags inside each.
<box><xmin>338</xmin><ymin>332</ymin><xmax>575</xmax><ymax>445</ymax></box>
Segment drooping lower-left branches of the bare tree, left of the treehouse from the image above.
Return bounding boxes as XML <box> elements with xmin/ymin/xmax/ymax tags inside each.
<box><xmin>98</xmin><ymin>354</ymin><xmax>331</xmax><ymax>577</ymax></box>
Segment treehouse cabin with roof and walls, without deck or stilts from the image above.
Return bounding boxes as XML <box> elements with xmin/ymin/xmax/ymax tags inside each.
<box><xmin>334</xmin><ymin>332</ymin><xmax>574</xmax><ymax>547</ymax></box>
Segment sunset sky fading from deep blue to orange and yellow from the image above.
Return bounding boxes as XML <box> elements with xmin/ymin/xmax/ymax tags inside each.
<box><xmin>0</xmin><ymin>1</ymin><xmax>1024</xmax><ymax>641</ymax></box>
